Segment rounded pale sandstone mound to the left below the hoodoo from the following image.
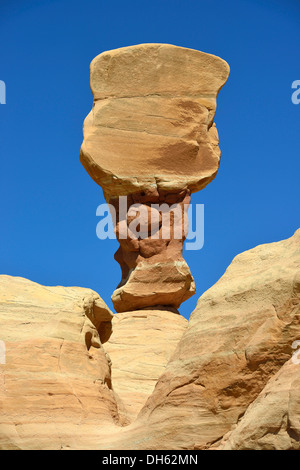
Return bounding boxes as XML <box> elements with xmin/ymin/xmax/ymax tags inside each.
<box><xmin>0</xmin><ymin>276</ymin><xmax>119</xmax><ymax>449</ymax></box>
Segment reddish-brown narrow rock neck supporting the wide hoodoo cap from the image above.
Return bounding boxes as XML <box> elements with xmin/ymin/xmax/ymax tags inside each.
<box><xmin>112</xmin><ymin>187</ymin><xmax>196</xmax><ymax>312</ymax></box>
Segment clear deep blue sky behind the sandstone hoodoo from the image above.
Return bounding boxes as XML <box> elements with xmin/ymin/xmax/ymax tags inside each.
<box><xmin>0</xmin><ymin>0</ymin><xmax>300</xmax><ymax>317</ymax></box>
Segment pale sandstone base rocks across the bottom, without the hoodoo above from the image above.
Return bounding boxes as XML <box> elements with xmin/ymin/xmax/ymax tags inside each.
<box><xmin>0</xmin><ymin>230</ymin><xmax>300</xmax><ymax>450</ymax></box>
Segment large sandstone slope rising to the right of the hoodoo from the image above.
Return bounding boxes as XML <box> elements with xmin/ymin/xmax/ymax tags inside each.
<box><xmin>112</xmin><ymin>230</ymin><xmax>300</xmax><ymax>449</ymax></box>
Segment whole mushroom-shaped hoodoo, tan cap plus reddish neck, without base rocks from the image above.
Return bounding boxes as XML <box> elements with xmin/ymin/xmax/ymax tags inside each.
<box><xmin>80</xmin><ymin>44</ymin><xmax>229</xmax><ymax>312</ymax></box>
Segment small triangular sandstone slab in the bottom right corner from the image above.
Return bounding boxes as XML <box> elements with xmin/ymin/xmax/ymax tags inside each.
<box><xmin>219</xmin><ymin>360</ymin><xmax>300</xmax><ymax>450</ymax></box>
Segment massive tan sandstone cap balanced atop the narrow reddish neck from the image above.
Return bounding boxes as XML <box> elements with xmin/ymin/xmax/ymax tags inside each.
<box><xmin>80</xmin><ymin>44</ymin><xmax>229</xmax><ymax>200</ymax></box>
